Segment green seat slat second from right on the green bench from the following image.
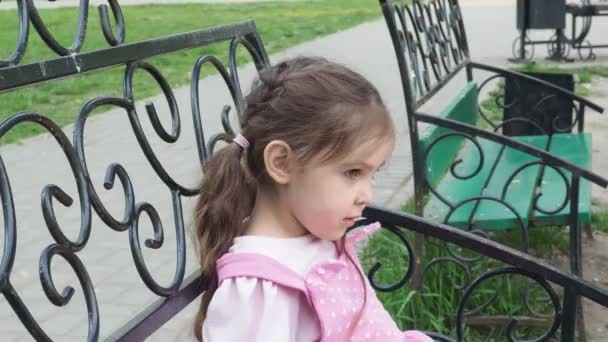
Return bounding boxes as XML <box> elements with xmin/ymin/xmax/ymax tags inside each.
<box><xmin>475</xmin><ymin>135</ymin><xmax>548</xmax><ymax>230</ymax></box>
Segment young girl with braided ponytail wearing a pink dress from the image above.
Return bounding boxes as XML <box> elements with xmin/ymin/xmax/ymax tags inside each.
<box><xmin>195</xmin><ymin>57</ymin><xmax>432</xmax><ymax>342</ymax></box>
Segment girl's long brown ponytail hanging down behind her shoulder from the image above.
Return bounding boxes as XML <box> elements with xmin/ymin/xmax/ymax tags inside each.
<box><xmin>194</xmin><ymin>143</ymin><xmax>256</xmax><ymax>341</ymax></box>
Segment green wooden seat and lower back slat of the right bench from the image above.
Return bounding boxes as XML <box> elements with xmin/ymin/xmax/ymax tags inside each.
<box><xmin>419</xmin><ymin>82</ymin><xmax>591</xmax><ymax>230</ymax></box>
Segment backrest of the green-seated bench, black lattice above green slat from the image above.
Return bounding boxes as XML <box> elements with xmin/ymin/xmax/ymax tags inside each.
<box><xmin>380</xmin><ymin>0</ymin><xmax>477</xmax><ymax>202</ymax></box>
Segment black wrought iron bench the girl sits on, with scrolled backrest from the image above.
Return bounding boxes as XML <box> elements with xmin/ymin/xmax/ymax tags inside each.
<box><xmin>0</xmin><ymin>1</ymin><xmax>608</xmax><ymax>341</ymax></box>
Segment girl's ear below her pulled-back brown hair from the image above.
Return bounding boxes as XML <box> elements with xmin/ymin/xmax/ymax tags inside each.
<box><xmin>264</xmin><ymin>140</ymin><xmax>294</xmax><ymax>184</ymax></box>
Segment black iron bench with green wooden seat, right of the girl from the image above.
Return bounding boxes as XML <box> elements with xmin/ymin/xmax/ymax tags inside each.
<box><xmin>380</xmin><ymin>0</ymin><xmax>603</xmax><ymax>272</ymax></box>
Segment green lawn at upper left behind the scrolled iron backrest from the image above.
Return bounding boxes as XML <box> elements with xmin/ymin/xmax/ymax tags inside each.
<box><xmin>0</xmin><ymin>0</ymin><xmax>381</xmax><ymax>144</ymax></box>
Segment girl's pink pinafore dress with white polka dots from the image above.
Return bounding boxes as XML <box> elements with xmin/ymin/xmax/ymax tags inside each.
<box><xmin>205</xmin><ymin>223</ymin><xmax>433</xmax><ymax>342</ymax></box>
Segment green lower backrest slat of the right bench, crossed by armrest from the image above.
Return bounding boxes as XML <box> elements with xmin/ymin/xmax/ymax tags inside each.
<box><xmin>418</xmin><ymin>82</ymin><xmax>477</xmax><ymax>184</ymax></box>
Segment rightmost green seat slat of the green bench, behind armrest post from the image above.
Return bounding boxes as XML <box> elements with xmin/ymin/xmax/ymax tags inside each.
<box><xmin>535</xmin><ymin>133</ymin><xmax>591</xmax><ymax>226</ymax></box>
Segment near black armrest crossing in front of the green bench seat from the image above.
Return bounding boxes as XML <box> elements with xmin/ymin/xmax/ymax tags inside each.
<box><xmin>414</xmin><ymin>112</ymin><xmax>608</xmax><ymax>188</ymax></box>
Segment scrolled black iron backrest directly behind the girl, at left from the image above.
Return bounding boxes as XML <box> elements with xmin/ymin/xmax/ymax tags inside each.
<box><xmin>0</xmin><ymin>1</ymin><xmax>268</xmax><ymax>341</ymax></box>
